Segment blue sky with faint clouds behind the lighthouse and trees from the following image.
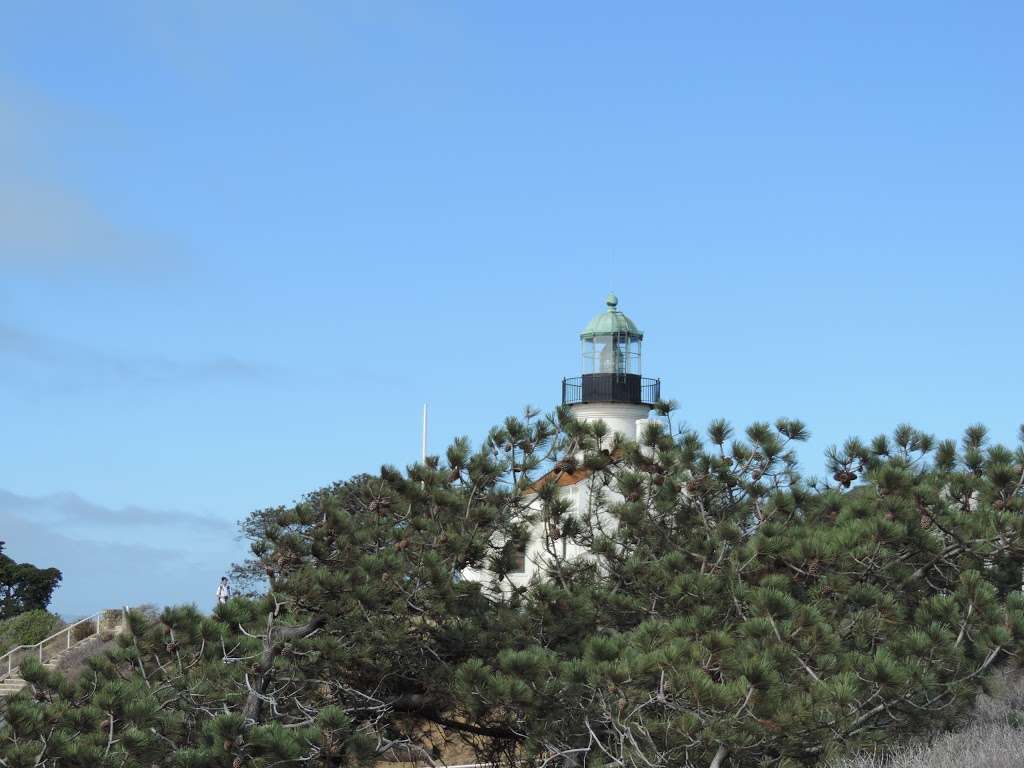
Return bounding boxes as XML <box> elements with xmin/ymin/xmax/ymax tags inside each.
<box><xmin>0</xmin><ymin>0</ymin><xmax>1024</xmax><ymax>613</ymax></box>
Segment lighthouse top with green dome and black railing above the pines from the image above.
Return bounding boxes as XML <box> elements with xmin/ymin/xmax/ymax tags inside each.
<box><xmin>562</xmin><ymin>293</ymin><xmax>662</xmax><ymax>440</ymax></box>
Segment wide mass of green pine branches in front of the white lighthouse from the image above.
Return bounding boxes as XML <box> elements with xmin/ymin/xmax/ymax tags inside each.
<box><xmin>0</xmin><ymin>415</ymin><xmax>1024</xmax><ymax>768</ymax></box>
